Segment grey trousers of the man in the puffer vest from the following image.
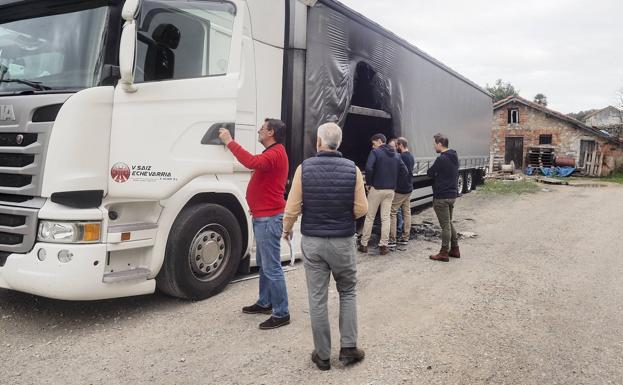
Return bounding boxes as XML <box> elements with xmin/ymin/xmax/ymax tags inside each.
<box><xmin>301</xmin><ymin>236</ymin><xmax>357</xmax><ymax>360</ymax></box>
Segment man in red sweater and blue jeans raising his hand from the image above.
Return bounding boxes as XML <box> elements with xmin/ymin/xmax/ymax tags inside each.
<box><xmin>219</xmin><ymin>119</ymin><xmax>290</xmax><ymax>329</ymax></box>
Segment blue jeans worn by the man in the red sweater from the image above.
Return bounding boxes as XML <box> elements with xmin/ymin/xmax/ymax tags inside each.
<box><xmin>253</xmin><ymin>214</ymin><xmax>289</xmax><ymax>318</ymax></box>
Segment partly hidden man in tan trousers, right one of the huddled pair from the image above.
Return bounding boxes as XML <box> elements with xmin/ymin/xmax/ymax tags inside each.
<box><xmin>389</xmin><ymin>137</ymin><xmax>415</xmax><ymax>246</ymax></box>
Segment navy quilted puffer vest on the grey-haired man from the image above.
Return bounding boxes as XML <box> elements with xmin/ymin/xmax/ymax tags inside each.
<box><xmin>301</xmin><ymin>151</ymin><xmax>357</xmax><ymax>238</ymax></box>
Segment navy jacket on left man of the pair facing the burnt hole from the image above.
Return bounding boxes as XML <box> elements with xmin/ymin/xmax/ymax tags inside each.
<box><xmin>366</xmin><ymin>144</ymin><xmax>407</xmax><ymax>190</ymax></box>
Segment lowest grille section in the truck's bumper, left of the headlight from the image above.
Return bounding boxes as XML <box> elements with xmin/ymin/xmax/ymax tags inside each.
<box><xmin>0</xmin><ymin>206</ymin><xmax>37</xmax><ymax>253</ymax></box>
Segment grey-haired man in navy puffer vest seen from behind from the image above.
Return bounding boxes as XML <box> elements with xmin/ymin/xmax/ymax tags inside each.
<box><xmin>283</xmin><ymin>123</ymin><xmax>368</xmax><ymax>370</ymax></box>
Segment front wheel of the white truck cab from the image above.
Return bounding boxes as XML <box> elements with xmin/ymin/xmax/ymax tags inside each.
<box><xmin>156</xmin><ymin>204</ymin><xmax>242</xmax><ymax>300</ymax></box>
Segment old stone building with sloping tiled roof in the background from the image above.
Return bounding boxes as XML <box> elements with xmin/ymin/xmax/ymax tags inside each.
<box><xmin>491</xmin><ymin>96</ymin><xmax>623</xmax><ymax>176</ymax></box>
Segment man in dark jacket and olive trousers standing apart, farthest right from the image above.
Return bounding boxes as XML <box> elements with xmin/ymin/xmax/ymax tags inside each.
<box><xmin>427</xmin><ymin>134</ymin><xmax>461</xmax><ymax>262</ymax></box>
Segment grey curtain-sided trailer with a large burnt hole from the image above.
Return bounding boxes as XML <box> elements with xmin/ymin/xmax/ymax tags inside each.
<box><xmin>284</xmin><ymin>0</ymin><xmax>493</xmax><ymax>205</ymax></box>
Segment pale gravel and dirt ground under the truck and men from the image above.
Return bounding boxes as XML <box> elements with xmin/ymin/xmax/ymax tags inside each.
<box><xmin>0</xmin><ymin>181</ymin><xmax>623</xmax><ymax>385</ymax></box>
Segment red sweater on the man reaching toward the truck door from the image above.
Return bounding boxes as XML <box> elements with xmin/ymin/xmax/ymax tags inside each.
<box><xmin>227</xmin><ymin>141</ymin><xmax>288</xmax><ymax>218</ymax></box>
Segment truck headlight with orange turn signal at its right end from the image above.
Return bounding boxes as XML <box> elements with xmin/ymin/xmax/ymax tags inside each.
<box><xmin>37</xmin><ymin>221</ymin><xmax>102</xmax><ymax>243</ymax></box>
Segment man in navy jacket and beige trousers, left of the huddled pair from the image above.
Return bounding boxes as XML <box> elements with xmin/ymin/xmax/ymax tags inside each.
<box><xmin>359</xmin><ymin>134</ymin><xmax>407</xmax><ymax>255</ymax></box>
